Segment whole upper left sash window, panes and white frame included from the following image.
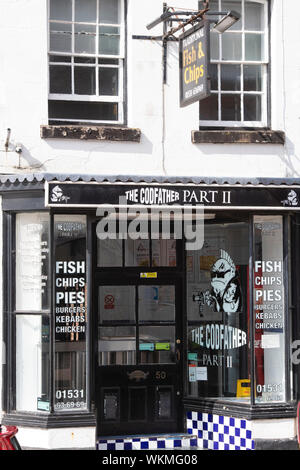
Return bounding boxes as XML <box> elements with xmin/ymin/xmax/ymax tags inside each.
<box><xmin>49</xmin><ymin>0</ymin><xmax>125</xmax><ymax>124</ymax></box>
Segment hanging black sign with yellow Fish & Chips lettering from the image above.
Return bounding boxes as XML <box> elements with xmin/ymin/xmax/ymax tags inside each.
<box><xmin>179</xmin><ymin>20</ymin><xmax>210</xmax><ymax>107</ymax></box>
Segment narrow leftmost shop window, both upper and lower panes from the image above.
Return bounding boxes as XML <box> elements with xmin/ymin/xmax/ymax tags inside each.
<box><xmin>14</xmin><ymin>212</ymin><xmax>50</xmax><ymax>412</ymax></box>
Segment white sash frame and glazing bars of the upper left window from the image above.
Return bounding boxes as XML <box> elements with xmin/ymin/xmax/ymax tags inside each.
<box><xmin>48</xmin><ymin>0</ymin><xmax>125</xmax><ymax>124</ymax></box>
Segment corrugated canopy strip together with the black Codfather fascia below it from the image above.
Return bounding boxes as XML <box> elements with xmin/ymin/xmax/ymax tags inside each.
<box><xmin>0</xmin><ymin>173</ymin><xmax>300</xmax><ymax>211</ymax></box>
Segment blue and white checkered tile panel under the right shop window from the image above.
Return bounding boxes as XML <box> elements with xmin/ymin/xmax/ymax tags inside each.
<box><xmin>187</xmin><ymin>411</ymin><xmax>254</xmax><ymax>450</ymax></box>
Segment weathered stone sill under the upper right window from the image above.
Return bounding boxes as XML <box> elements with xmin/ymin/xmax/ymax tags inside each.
<box><xmin>192</xmin><ymin>129</ymin><xmax>285</xmax><ymax>145</ymax></box>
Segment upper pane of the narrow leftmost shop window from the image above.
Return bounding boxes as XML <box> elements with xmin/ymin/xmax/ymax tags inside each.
<box><xmin>16</xmin><ymin>212</ymin><xmax>50</xmax><ymax>312</ymax></box>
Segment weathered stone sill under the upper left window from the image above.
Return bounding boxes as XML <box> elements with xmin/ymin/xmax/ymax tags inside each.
<box><xmin>41</xmin><ymin>125</ymin><xmax>141</xmax><ymax>142</ymax></box>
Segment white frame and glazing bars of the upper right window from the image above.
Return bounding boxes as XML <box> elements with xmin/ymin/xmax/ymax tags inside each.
<box><xmin>199</xmin><ymin>0</ymin><xmax>269</xmax><ymax>128</ymax></box>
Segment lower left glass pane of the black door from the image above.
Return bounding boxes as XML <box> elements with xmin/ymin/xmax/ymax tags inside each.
<box><xmin>98</xmin><ymin>326</ymin><xmax>136</xmax><ymax>366</ymax></box>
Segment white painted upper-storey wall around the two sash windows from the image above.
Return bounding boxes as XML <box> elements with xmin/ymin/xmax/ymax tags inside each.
<box><xmin>0</xmin><ymin>0</ymin><xmax>300</xmax><ymax>177</ymax></box>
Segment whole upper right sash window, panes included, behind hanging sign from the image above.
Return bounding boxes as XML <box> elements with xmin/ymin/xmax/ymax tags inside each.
<box><xmin>200</xmin><ymin>0</ymin><xmax>269</xmax><ymax>128</ymax></box>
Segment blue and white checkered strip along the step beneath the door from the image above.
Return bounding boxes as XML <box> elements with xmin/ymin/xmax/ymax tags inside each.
<box><xmin>96</xmin><ymin>433</ymin><xmax>197</xmax><ymax>450</ymax></box>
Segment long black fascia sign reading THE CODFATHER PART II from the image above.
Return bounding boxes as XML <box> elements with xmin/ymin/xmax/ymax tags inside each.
<box><xmin>46</xmin><ymin>182</ymin><xmax>300</xmax><ymax>210</ymax></box>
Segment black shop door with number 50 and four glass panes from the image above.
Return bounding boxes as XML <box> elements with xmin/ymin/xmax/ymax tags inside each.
<box><xmin>96</xmin><ymin>278</ymin><xmax>182</xmax><ymax>436</ymax></box>
